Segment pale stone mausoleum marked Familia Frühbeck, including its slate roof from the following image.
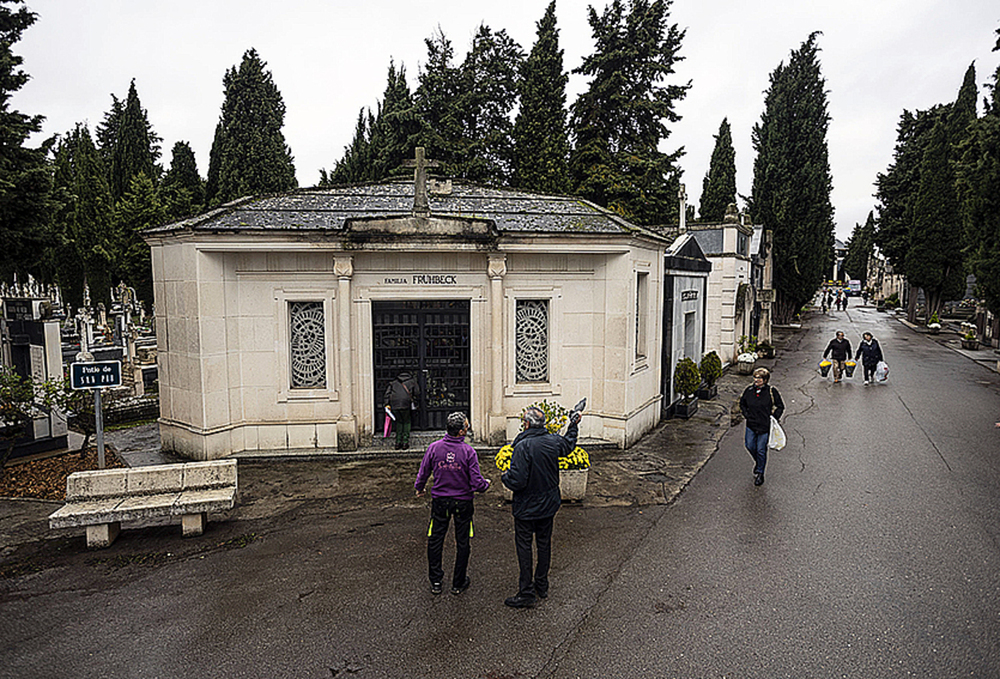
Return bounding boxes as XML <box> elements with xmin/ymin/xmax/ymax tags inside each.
<box><xmin>145</xmin><ymin>156</ymin><xmax>704</xmax><ymax>460</ymax></box>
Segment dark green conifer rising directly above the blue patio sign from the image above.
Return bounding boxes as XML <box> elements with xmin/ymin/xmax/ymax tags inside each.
<box><xmin>54</xmin><ymin>124</ymin><xmax>116</xmax><ymax>306</ymax></box>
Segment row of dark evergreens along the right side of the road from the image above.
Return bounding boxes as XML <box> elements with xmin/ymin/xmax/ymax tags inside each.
<box><xmin>844</xmin><ymin>29</ymin><xmax>1000</xmax><ymax>321</ymax></box>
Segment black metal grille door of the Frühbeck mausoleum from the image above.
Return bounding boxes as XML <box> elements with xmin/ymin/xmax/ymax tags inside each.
<box><xmin>372</xmin><ymin>300</ymin><xmax>471</xmax><ymax>431</ymax></box>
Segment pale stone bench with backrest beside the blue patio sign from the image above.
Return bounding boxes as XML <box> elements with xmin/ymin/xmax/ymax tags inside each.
<box><xmin>49</xmin><ymin>460</ymin><xmax>236</xmax><ymax>549</ymax></box>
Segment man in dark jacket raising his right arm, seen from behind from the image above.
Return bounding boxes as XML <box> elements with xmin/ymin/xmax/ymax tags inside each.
<box><xmin>500</xmin><ymin>407</ymin><xmax>581</xmax><ymax>608</ymax></box>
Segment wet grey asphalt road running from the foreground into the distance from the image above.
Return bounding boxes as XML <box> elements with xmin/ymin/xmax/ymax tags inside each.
<box><xmin>0</xmin><ymin>308</ymin><xmax>1000</xmax><ymax>679</ymax></box>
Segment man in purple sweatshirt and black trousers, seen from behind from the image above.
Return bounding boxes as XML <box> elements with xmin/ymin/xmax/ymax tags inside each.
<box><xmin>413</xmin><ymin>413</ymin><xmax>490</xmax><ymax>594</ymax></box>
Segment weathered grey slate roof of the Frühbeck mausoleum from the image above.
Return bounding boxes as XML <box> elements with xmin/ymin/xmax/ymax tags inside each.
<box><xmin>146</xmin><ymin>180</ymin><xmax>664</xmax><ymax>240</ymax></box>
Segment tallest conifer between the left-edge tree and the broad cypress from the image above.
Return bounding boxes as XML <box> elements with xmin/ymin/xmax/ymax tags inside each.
<box><xmin>102</xmin><ymin>80</ymin><xmax>162</xmax><ymax>200</ymax></box>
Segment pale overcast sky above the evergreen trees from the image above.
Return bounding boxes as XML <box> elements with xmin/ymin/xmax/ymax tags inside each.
<box><xmin>13</xmin><ymin>0</ymin><xmax>1000</xmax><ymax>240</ymax></box>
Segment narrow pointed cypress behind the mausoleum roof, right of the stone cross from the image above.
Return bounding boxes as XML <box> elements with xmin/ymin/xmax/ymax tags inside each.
<box><xmin>511</xmin><ymin>0</ymin><xmax>572</xmax><ymax>195</ymax></box>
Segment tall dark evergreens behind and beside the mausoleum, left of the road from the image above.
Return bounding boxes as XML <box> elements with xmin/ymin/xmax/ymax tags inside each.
<box><xmin>0</xmin><ymin>0</ymin><xmax>852</xmax><ymax>322</ymax></box>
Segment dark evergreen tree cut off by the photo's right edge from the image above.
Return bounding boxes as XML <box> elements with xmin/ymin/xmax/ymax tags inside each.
<box><xmin>957</xmin><ymin>62</ymin><xmax>1000</xmax><ymax>316</ymax></box>
